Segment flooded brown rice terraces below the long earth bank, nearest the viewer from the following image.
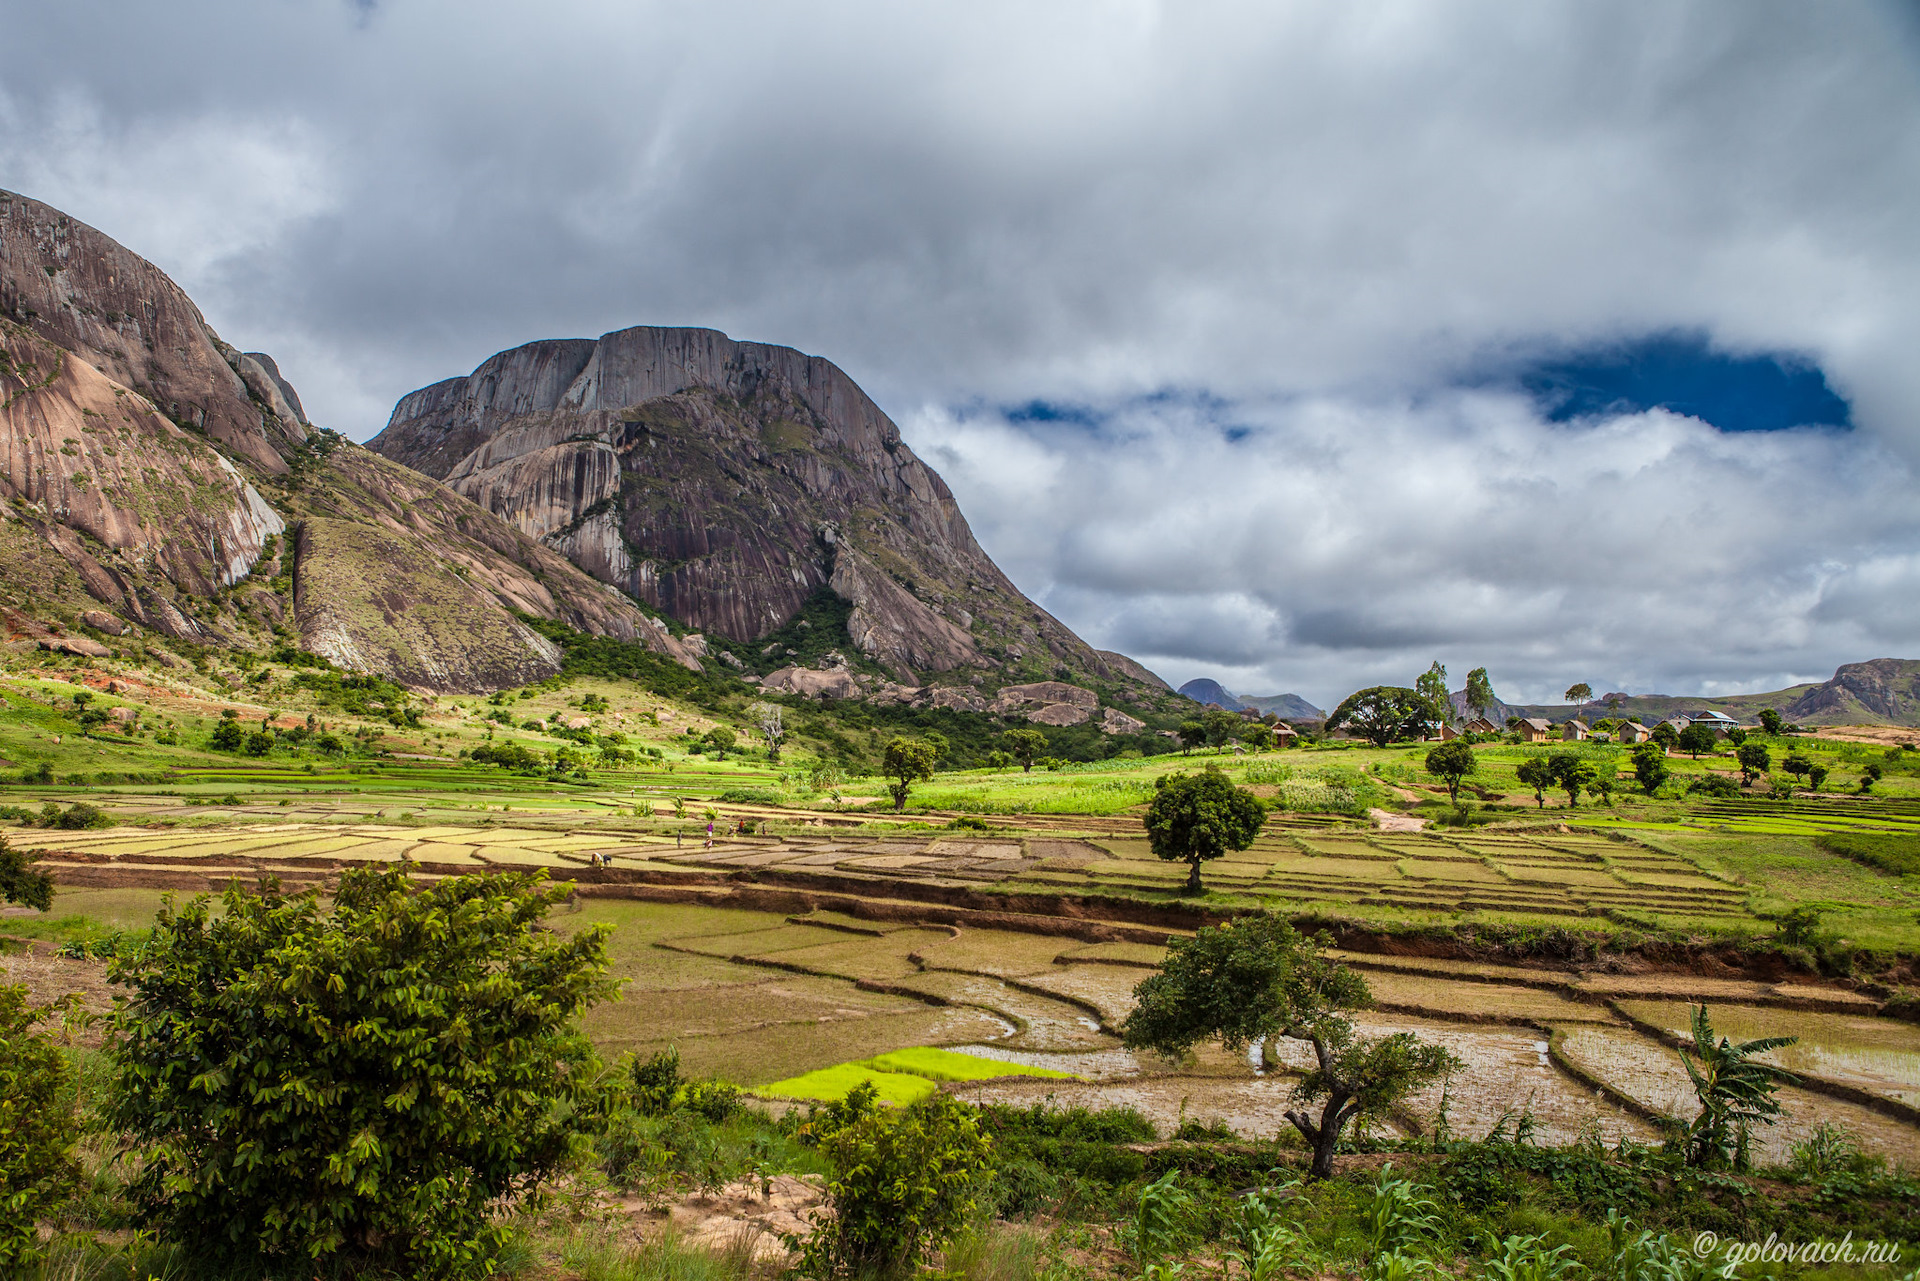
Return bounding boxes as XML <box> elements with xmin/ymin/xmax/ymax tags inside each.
<box><xmin>15</xmin><ymin>887</ymin><xmax>1920</xmax><ymax>1164</ymax></box>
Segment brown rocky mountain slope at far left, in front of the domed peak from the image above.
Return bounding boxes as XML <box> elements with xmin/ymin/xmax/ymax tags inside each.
<box><xmin>0</xmin><ymin>192</ymin><xmax>697</xmax><ymax>689</ymax></box>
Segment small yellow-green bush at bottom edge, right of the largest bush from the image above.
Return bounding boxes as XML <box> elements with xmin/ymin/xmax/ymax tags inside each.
<box><xmin>797</xmin><ymin>1095</ymin><xmax>993</xmax><ymax>1281</ymax></box>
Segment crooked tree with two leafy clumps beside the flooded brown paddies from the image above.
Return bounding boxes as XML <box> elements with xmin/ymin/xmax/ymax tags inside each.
<box><xmin>1121</xmin><ymin>912</ymin><xmax>1459</xmax><ymax>1179</ymax></box>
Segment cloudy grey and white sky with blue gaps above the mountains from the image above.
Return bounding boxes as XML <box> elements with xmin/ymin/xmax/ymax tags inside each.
<box><xmin>0</xmin><ymin>0</ymin><xmax>1920</xmax><ymax>707</ymax></box>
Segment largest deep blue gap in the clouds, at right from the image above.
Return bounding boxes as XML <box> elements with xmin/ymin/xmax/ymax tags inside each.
<box><xmin>1519</xmin><ymin>334</ymin><xmax>1853</xmax><ymax>432</ymax></box>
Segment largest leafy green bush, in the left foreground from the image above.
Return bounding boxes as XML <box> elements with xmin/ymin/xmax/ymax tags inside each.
<box><xmin>113</xmin><ymin>868</ymin><xmax>611</xmax><ymax>1275</ymax></box>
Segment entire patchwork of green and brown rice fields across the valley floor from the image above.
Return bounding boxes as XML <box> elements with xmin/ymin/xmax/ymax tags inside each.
<box><xmin>0</xmin><ymin>652</ymin><xmax>1920</xmax><ymax>1164</ymax></box>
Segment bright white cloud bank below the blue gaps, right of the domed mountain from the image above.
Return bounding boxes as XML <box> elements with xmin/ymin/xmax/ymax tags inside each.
<box><xmin>908</xmin><ymin>392</ymin><xmax>1920</xmax><ymax>705</ymax></box>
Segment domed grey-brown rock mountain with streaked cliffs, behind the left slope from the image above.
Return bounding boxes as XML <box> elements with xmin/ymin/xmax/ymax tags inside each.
<box><xmin>369</xmin><ymin>328</ymin><xmax>1164</xmax><ymax>689</ymax></box>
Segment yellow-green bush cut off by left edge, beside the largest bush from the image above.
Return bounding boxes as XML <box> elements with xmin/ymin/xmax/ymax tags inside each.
<box><xmin>0</xmin><ymin>985</ymin><xmax>81</xmax><ymax>1277</ymax></box>
